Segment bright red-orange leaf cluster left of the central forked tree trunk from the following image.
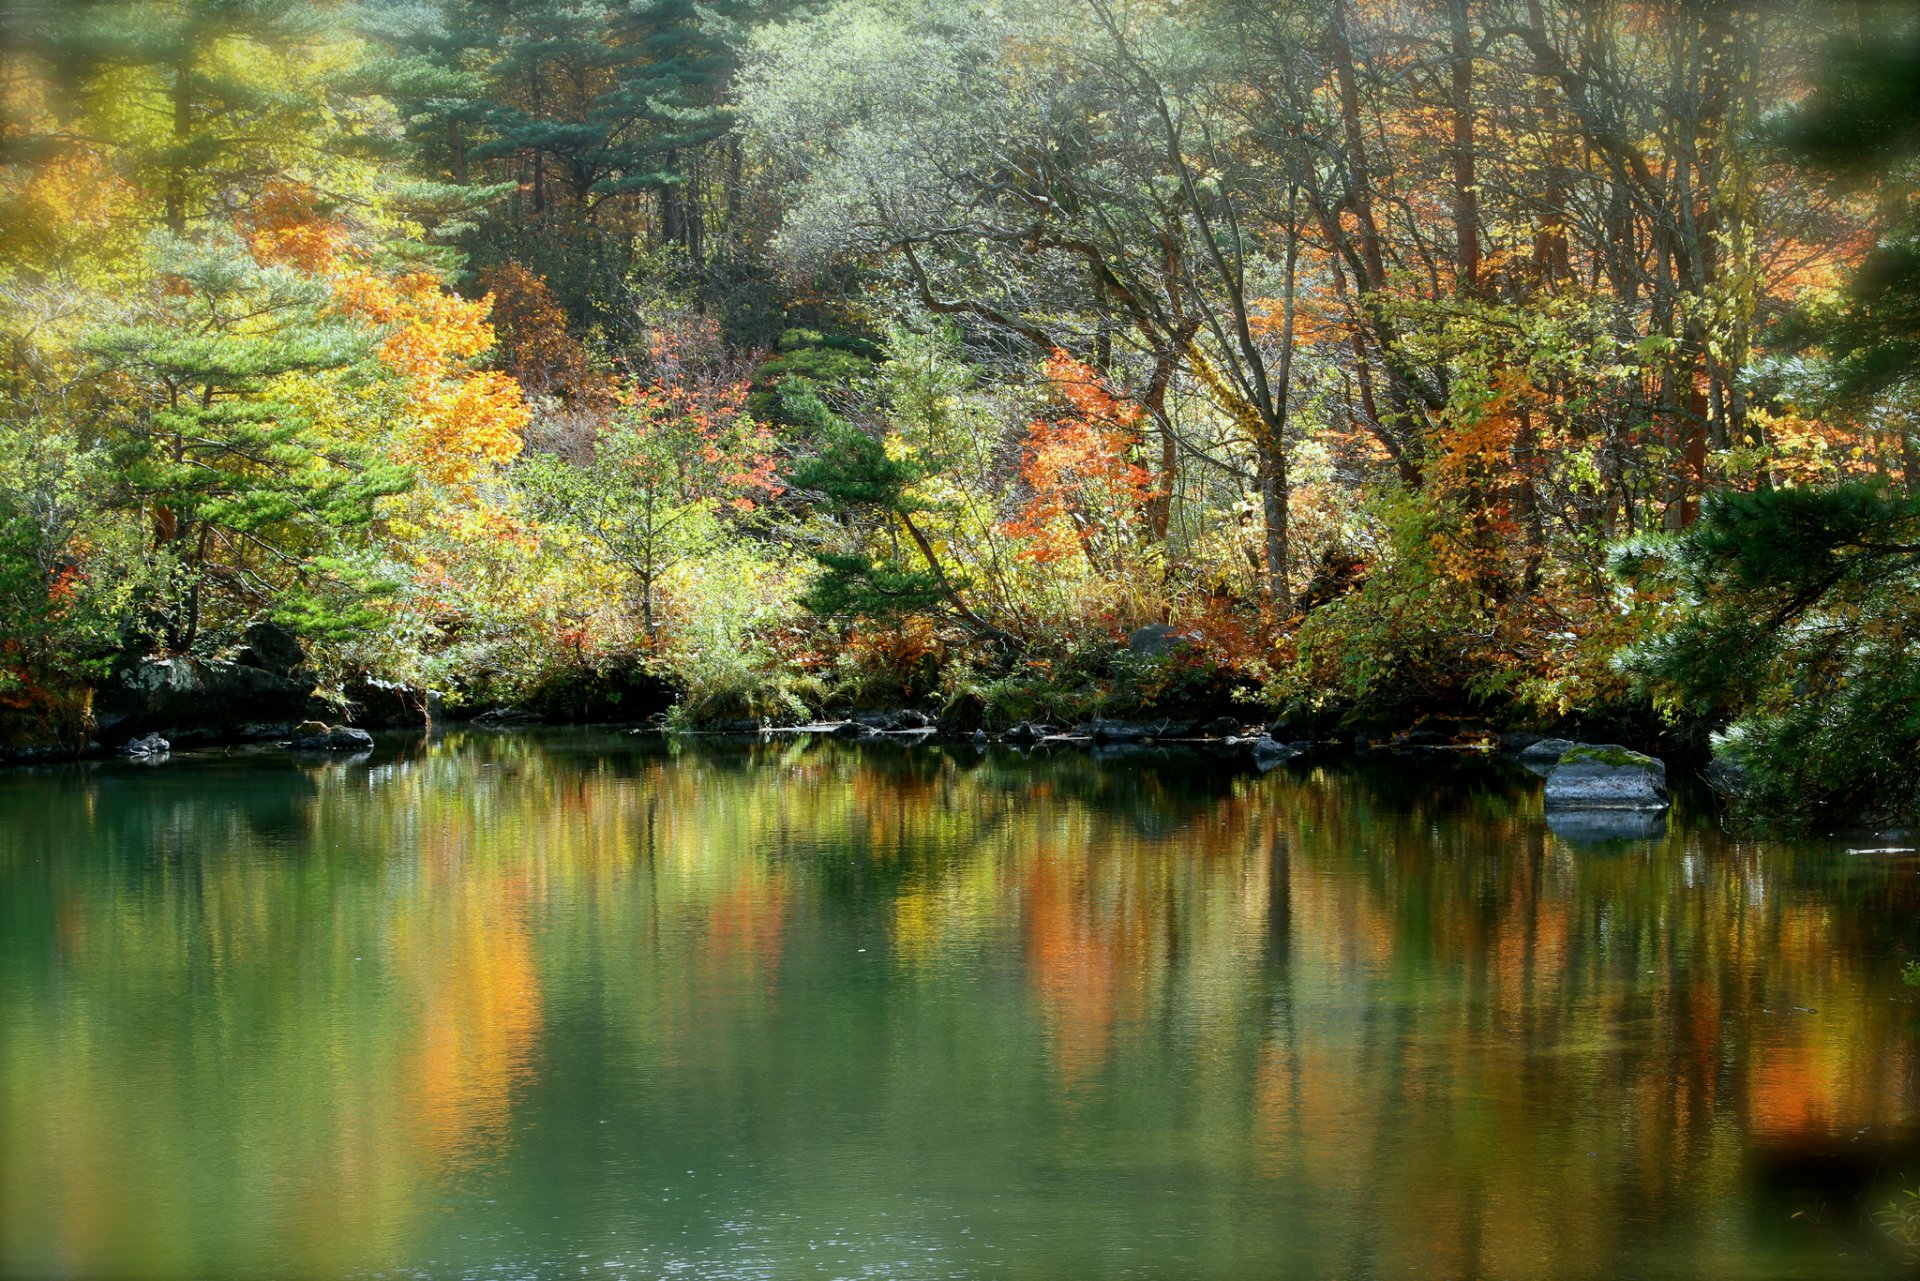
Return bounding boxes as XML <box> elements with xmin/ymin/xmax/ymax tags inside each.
<box><xmin>1002</xmin><ymin>351</ymin><xmax>1154</xmax><ymax>565</ymax></box>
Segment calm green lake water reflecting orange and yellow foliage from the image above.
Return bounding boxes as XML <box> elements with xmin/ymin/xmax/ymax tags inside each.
<box><xmin>0</xmin><ymin>732</ymin><xmax>1920</xmax><ymax>1281</ymax></box>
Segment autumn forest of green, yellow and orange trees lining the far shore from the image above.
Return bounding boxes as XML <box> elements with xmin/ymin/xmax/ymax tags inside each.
<box><xmin>0</xmin><ymin>0</ymin><xmax>1920</xmax><ymax>826</ymax></box>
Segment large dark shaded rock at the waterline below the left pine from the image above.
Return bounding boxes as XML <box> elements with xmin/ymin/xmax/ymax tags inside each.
<box><xmin>94</xmin><ymin>657</ymin><xmax>313</xmax><ymax>745</ymax></box>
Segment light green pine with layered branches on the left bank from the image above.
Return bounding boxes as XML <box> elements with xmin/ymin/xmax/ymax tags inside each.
<box><xmin>86</xmin><ymin>234</ymin><xmax>411</xmax><ymax>649</ymax></box>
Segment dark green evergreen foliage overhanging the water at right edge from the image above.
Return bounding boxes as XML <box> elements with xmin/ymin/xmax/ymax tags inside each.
<box><xmin>1620</xmin><ymin>484</ymin><xmax>1920</xmax><ymax>824</ymax></box>
